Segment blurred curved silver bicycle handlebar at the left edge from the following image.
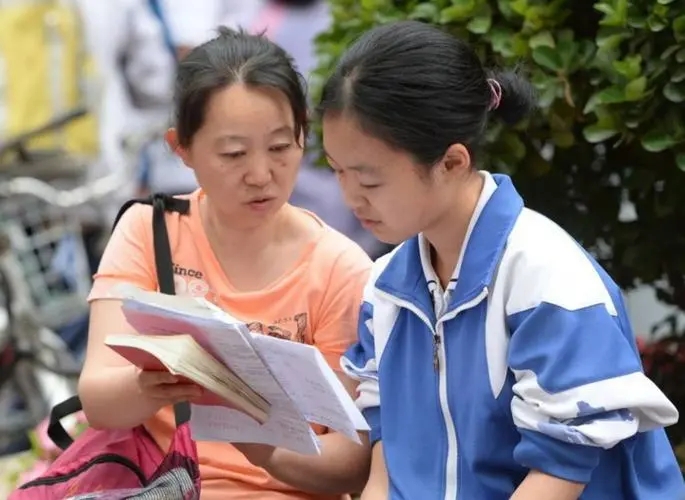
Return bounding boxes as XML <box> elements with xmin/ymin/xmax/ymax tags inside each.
<box><xmin>0</xmin><ymin>174</ymin><xmax>122</xmax><ymax>209</ymax></box>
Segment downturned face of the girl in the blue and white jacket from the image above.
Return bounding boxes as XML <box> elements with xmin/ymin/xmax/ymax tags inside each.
<box><xmin>323</xmin><ymin>113</ymin><xmax>455</xmax><ymax>243</ymax></box>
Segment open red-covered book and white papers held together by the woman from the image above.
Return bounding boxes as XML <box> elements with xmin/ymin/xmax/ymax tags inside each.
<box><xmin>105</xmin><ymin>287</ymin><xmax>369</xmax><ymax>454</ymax></box>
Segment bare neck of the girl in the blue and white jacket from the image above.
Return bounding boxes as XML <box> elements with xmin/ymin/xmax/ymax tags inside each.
<box><xmin>423</xmin><ymin>171</ymin><xmax>484</xmax><ymax>287</ymax></box>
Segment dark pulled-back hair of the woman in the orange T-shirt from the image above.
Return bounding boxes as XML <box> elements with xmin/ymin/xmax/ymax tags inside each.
<box><xmin>174</xmin><ymin>26</ymin><xmax>307</xmax><ymax>147</ymax></box>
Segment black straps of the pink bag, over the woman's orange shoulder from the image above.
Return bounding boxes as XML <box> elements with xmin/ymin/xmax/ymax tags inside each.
<box><xmin>47</xmin><ymin>194</ymin><xmax>190</xmax><ymax>450</ymax></box>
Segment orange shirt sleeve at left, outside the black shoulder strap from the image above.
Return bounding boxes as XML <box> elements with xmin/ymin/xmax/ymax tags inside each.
<box><xmin>88</xmin><ymin>205</ymin><xmax>157</xmax><ymax>302</ymax></box>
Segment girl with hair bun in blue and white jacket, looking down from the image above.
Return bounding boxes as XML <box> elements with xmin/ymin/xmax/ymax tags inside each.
<box><xmin>321</xmin><ymin>22</ymin><xmax>685</xmax><ymax>500</ymax></box>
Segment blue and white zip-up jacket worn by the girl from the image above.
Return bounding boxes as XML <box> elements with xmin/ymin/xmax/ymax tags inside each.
<box><xmin>342</xmin><ymin>174</ymin><xmax>685</xmax><ymax>500</ymax></box>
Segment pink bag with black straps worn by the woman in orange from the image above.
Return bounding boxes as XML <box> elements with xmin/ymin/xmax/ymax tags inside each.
<box><xmin>8</xmin><ymin>194</ymin><xmax>200</xmax><ymax>500</ymax></box>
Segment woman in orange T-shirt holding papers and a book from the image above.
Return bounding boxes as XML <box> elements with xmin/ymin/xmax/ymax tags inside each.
<box><xmin>79</xmin><ymin>28</ymin><xmax>370</xmax><ymax>500</ymax></box>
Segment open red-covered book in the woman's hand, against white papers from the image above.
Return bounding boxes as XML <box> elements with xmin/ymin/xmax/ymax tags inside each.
<box><xmin>105</xmin><ymin>334</ymin><xmax>271</xmax><ymax>424</ymax></box>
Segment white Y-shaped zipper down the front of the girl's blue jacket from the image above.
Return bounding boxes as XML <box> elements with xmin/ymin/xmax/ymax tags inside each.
<box><xmin>376</xmin><ymin>287</ymin><xmax>489</xmax><ymax>500</ymax></box>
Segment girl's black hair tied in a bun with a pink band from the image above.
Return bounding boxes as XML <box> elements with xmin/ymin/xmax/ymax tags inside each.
<box><xmin>319</xmin><ymin>21</ymin><xmax>535</xmax><ymax>166</ymax></box>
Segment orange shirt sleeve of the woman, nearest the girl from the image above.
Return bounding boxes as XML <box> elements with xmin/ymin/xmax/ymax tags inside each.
<box><xmin>312</xmin><ymin>240</ymin><xmax>372</xmax><ymax>371</ymax></box>
